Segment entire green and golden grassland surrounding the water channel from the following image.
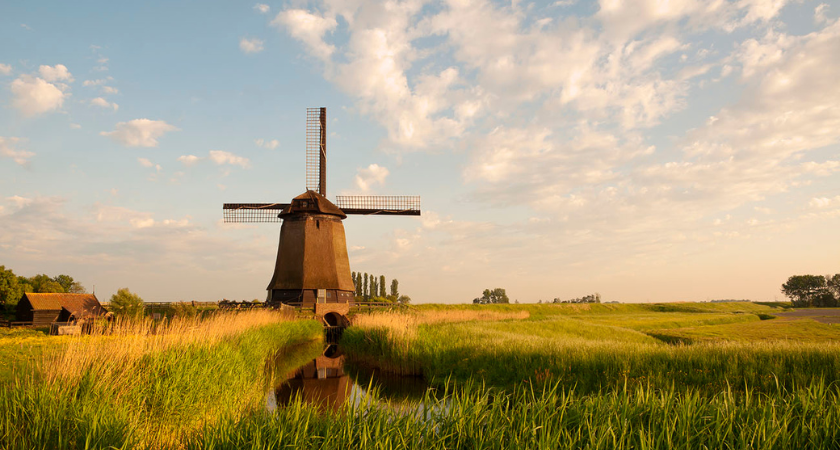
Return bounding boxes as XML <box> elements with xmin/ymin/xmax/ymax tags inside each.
<box><xmin>0</xmin><ymin>302</ymin><xmax>840</xmax><ymax>449</ymax></box>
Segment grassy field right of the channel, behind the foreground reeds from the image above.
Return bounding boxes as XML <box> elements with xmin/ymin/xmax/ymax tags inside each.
<box><xmin>342</xmin><ymin>303</ymin><xmax>840</xmax><ymax>394</ymax></box>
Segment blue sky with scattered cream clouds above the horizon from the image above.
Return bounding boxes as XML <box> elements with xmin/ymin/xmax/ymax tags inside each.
<box><xmin>0</xmin><ymin>0</ymin><xmax>840</xmax><ymax>303</ymax></box>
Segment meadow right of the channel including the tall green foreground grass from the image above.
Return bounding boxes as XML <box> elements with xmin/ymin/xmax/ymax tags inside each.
<box><xmin>199</xmin><ymin>303</ymin><xmax>840</xmax><ymax>449</ymax></box>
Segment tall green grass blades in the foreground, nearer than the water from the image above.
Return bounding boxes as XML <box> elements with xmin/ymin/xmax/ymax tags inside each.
<box><xmin>194</xmin><ymin>384</ymin><xmax>840</xmax><ymax>450</ymax></box>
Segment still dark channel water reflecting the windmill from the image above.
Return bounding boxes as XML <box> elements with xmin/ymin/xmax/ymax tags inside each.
<box><xmin>268</xmin><ymin>344</ymin><xmax>427</xmax><ymax>411</ymax></box>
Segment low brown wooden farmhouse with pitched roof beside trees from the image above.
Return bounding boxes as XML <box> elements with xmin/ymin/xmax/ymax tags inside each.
<box><xmin>16</xmin><ymin>292</ymin><xmax>108</xmax><ymax>326</ymax></box>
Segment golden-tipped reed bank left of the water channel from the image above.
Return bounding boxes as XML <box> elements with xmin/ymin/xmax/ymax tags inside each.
<box><xmin>0</xmin><ymin>311</ymin><xmax>323</xmax><ymax>449</ymax></box>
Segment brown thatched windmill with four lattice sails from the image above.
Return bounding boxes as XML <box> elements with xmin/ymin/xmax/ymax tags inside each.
<box><xmin>222</xmin><ymin>108</ymin><xmax>420</xmax><ymax>309</ymax></box>
